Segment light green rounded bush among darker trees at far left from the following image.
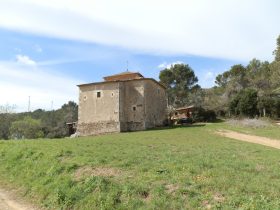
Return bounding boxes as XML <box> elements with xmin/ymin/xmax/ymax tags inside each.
<box><xmin>10</xmin><ymin>117</ymin><xmax>44</xmax><ymax>139</ymax></box>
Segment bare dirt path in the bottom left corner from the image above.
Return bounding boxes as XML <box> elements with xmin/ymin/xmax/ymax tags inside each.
<box><xmin>0</xmin><ymin>189</ymin><xmax>35</xmax><ymax>210</ymax></box>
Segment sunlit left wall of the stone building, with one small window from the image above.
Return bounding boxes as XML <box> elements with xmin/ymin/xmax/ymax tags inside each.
<box><xmin>77</xmin><ymin>83</ymin><xmax>120</xmax><ymax>136</ymax></box>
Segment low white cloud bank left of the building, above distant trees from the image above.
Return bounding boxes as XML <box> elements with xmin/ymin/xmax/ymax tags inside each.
<box><xmin>0</xmin><ymin>62</ymin><xmax>83</xmax><ymax>112</ymax></box>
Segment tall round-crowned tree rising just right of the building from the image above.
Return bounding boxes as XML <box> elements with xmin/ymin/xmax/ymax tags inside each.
<box><xmin>159</xmin><ymin>64</ymin><xmax>200</xmax><ymax>106</ymax></box>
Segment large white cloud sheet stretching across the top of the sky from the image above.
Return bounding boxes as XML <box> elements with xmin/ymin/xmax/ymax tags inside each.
<box><xmin>0</xmin><ymin>0</ymin><xmax>280</xmax><ymax>60</ymax></box>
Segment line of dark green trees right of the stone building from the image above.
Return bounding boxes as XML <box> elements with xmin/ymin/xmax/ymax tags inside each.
<box><xmin>159</xmin><ymin>36</ymin><xmax>280</xmax><ymax>119</ymax></box>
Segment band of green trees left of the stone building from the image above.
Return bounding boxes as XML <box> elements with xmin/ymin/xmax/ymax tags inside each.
<box><xmin>0</xmin><ymin>101</ymin><xmax>78</xmax><ymax>139</ymax></box>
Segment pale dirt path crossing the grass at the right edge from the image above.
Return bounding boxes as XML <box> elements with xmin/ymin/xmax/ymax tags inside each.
<box><xmin>215</xmin><ymin>130</ymin><xmax>280</xmax><ymax>149</ymax></box>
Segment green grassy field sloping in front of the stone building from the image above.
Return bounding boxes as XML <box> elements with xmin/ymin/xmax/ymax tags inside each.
<box><xmin>0</xmin><ymin>123</ymin><xmax>280</xmax><ymax>210</ymax></box>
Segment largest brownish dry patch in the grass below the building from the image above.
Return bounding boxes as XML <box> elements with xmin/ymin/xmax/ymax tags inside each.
<box><xmin>74</xmin><ymin>166</ymin><xmax>122</xmax><ymax>180</ymax></box>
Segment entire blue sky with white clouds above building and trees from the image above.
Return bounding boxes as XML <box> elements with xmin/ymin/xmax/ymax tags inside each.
<box><xmin>0</xmin><ymin>0</ymin><xmax>280</xmax><ymax>112</ymax></box>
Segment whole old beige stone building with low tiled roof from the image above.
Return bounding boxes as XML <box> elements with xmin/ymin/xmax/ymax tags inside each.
<box><xmin>77</xmin><ymin>72</ymin><xmax>167</xmax><ymax>136</ymax></box>
